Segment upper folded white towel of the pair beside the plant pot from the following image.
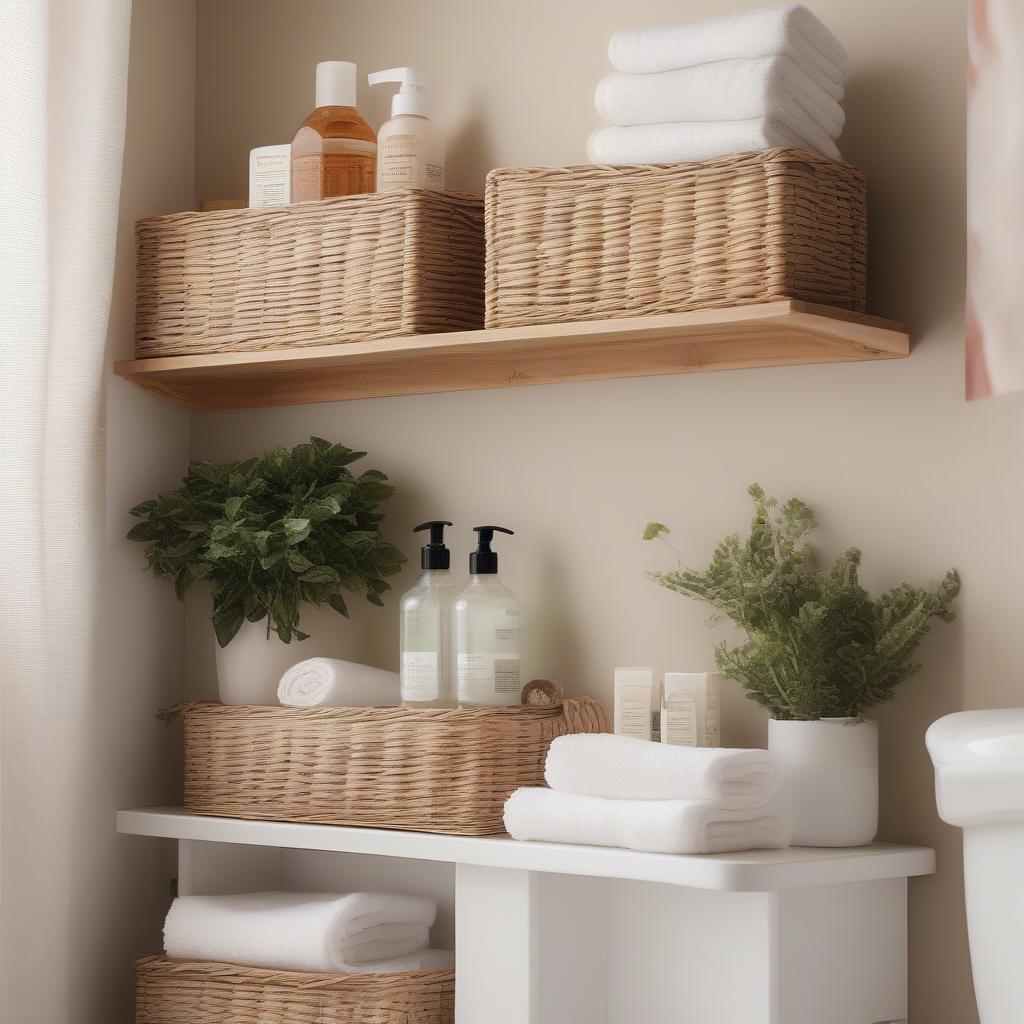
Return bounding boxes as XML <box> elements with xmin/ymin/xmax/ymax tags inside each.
<box><xmin>544</xmin><ymin>733</ymin><xmax>782</xmax><ymax>811</ymax></box>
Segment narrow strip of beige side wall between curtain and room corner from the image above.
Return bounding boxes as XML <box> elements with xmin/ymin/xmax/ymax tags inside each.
<box><xmin>98</xmin><ymin>0</ymin><xmax>196</xmax><ymax>1022</ymax></box>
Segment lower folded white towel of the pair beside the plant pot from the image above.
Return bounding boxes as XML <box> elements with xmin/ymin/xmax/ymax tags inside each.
<box><xmin>505</xmin><ymin>788</ymin><xmax>793</xmax><ymax>853</ymax></box>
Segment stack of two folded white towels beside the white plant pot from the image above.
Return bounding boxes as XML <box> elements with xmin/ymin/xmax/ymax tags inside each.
<box><xmin>505</xmin><ymin>734</ymin><xmax>793</xmax><ymax>853</ymax></box>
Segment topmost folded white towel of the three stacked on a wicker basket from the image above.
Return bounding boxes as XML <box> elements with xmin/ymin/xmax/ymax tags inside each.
<box><xmin>608</xmin><ymin>4</ymin><xmax>848</xmax><ymax>99</ymax></box>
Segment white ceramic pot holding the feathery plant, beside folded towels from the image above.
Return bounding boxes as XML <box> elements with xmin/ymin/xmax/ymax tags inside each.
<box><xmin>768</xmin><ymin>718</ymin><xmax>879</xmax><ymax>846</ymax></box>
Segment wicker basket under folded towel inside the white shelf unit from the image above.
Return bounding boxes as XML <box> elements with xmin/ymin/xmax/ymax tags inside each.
<box><xmin>135</xmin><ymin>956</ymin><xmax>455</xmax><ymax>1024</ymax></box>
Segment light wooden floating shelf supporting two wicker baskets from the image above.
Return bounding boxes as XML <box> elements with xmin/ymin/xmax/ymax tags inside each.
<box><xmin>114</xmin><ymin>299</ymin><xmax>910</xmax><ymax>410</ymax></box>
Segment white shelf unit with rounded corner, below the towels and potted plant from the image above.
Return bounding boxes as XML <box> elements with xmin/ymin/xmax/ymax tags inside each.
<box><xmin>118</xmin><ymin>807</ymin><xmax>935</xmax><ymax>1024</ymax></box>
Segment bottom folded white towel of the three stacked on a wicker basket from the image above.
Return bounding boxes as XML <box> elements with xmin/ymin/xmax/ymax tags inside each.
<box><xmin>587</xmin><ymin>118</ymin><xmax>843</xmax><ymax>164</ymax></box>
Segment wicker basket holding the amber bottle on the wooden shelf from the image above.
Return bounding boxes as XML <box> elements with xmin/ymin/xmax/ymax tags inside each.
<box><xmin>135</xmin><ymin>188</ymin><xmax>483</xmax><ymax>357</ymax></box>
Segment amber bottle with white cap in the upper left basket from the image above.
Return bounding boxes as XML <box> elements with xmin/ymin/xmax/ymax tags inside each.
<box><xmin>292</xmin><ymin>60</ymin><xmax>377</xmax><ymax>203</ymax></box>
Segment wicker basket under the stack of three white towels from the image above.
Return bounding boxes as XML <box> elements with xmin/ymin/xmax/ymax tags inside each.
<box><xmin>485</xmin><ymin>150</ymin><xmax>867</xmax><ymax>328</ymax></box>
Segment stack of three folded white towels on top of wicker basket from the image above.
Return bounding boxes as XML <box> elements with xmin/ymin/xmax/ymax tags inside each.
<box><xmin>587</xmin><ymin>4</ymin><xmax>847</xmax><ymax>164</ymax></box>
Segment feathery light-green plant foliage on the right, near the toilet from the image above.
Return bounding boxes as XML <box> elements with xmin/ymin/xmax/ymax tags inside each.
<box><xmin>643</xmin><ymin>484</ymin><xmax>961</xmax><ymax>720</ymax></box>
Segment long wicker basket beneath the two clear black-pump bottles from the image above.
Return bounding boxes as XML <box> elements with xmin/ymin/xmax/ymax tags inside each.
<box><xmin>184</xmin><ymin>697</ymin><xmax>610</xmax><ymax>836</ymax></box>
